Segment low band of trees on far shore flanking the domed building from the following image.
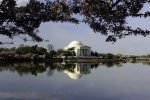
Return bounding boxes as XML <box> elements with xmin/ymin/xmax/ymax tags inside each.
<box><xmin>0</xmin><ymin>44</ymin><xmax>125</xmax><ymax>61</ymax></box>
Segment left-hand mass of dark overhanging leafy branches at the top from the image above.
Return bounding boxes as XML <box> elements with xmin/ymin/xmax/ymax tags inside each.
<box><xmin>0</xmin><ymin>0</ymin><xmax>78</xmax><ymax>44</ymax></box>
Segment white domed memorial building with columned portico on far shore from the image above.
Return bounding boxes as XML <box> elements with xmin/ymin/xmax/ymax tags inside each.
<box><xmin>65</xmin><ymin>41</ymin><xmax>91</xmax><ymax>57</ymax></box>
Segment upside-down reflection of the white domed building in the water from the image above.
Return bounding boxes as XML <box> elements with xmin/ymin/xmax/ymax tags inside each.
<box><xmin>64</xmin><ymin>63</ymin><xmax>92</xmax><ymax>80</ymax></box>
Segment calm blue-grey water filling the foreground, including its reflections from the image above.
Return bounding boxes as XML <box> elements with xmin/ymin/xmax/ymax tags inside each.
<box><xmin>0</xmin><ymin>62</ymin><xmax>150</xmax><ymax>100</ymax></box>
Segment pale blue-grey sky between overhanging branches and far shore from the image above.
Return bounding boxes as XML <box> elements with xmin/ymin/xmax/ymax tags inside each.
<box><xmin>0</xmin><ymin>0</ymin><xmax>150</xmax><ymax>55</ymax></box>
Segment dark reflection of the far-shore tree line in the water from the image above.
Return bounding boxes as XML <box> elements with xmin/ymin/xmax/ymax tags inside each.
<box><xmin>0</xmin><ymin>62</ymin><xmax>125</xmax><ymax>76</ymax></box>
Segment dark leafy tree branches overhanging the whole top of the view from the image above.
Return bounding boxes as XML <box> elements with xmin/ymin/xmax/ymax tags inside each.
<box><xmin>0</xmin><ymin>0</ymin><xmax>150</xmax><ymax>44</ymax></box>
